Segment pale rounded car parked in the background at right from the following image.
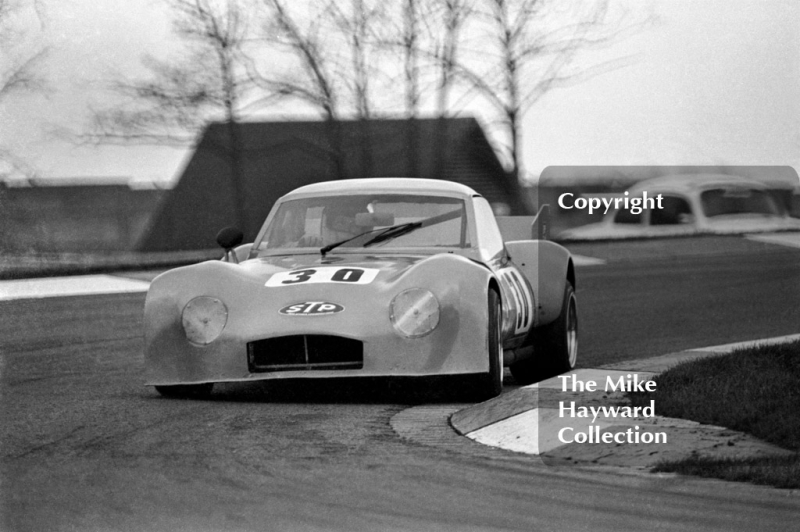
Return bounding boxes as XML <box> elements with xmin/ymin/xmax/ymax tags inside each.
<box><xmin>557</xmin><ymin>174</ymin><xmax>800</xmax><ymax>240</ymax></box>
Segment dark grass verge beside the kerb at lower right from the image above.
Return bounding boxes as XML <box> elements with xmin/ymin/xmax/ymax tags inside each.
<box><xmin>630</xmin><ymin>341</ymin><xmax>800</xmax><ymax>488</ymax></box>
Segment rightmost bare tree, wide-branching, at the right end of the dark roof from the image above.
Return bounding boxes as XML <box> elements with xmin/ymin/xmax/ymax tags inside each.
<box><xmin>453</xmin><ymin>0</ymin><xmax>641</xmax><ymax>189</ymax></box>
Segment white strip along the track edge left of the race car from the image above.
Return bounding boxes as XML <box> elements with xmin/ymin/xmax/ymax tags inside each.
<box><xmin>0</xmin><ymin>275</ymin><xmax>150</xmax><ymax>301</ymax></box>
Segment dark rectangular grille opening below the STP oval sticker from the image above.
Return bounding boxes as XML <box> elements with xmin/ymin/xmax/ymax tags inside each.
<box><xmin>247</xmin><ymin>334</ymin><xmax>364</xmax><ymax>373</ymax></box>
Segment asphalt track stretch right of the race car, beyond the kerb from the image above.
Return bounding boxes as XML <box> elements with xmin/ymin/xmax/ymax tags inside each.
<box><xmin>569</xmin><ymin>237</ymin><xmax>800</xmax><ymax>367</ymax></box>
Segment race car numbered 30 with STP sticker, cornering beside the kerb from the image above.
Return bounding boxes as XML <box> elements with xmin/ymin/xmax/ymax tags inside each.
<box><xmin>144</xmin><ymin>178</ymin><xmax>578</xmax><ymax>398</ymax></box>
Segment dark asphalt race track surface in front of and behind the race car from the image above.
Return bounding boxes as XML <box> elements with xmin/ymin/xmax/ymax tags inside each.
<box><xmin>0</xmin><ymin>239</ymin><xmax>800</xmax><ymax>531</ymax></box>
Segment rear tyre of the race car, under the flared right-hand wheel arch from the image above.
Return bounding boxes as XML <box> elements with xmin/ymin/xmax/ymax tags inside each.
<box><xmin>511</xmin><ymin>281</ymin><xmax>578</xmax><ymax>385</ymax></box>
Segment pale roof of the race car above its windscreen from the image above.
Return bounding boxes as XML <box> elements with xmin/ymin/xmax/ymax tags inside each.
<box><xmin>284</xmin><ymin>177</ymin><xmax>480</xmax><ymax>198</ymax></box>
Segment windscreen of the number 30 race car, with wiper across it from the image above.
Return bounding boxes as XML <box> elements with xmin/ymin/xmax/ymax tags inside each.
<box><xmin>256</xmin><ymin>194</ymin><xmax>469</xmax><ymax>251</ymax></box>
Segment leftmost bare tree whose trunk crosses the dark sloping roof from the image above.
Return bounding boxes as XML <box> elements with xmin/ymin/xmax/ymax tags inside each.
<box><xmin>86</xmin><ymin>0</ymin><xmax>267</xmax><ymax>229</ymax></box>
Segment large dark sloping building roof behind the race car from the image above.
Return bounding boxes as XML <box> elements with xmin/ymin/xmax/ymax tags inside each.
<box><xmin>138</xmin><ymin>118</ymin><xmax>527</xmax><ymax>251</ymax></box>
